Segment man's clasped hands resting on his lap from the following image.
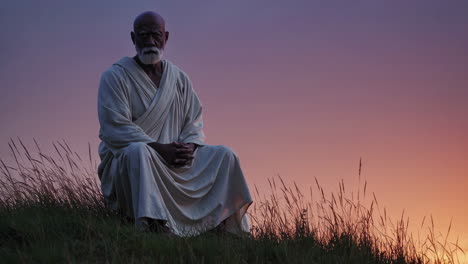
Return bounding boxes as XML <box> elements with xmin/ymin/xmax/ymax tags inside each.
<box><xmin>148</xmin><ymin>142</ymin><xmax>196</xmax><ymax>168</ymax></box>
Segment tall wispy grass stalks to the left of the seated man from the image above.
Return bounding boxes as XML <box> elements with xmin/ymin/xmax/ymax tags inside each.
<box><xmin>0</xmin><ymin>139</ymin><xmax>106</xmax><ymax>213</ymax></box>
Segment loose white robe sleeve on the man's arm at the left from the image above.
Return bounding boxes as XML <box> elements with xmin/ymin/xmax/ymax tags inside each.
<box><xmin>98</xmin><ymin>69</ymin><xmax>156</xmax><ymax>152</ymax></box>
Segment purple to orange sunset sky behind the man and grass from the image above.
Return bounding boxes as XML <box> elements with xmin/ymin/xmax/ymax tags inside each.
<box><xmin>0</xmin><ymin>0</ymin><xmax>468</xmax><ymax>256</ymax></box>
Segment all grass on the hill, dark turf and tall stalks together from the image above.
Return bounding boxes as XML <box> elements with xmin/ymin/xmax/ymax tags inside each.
<box><xmin>0</xmin><ymin>141</ymin><xmax>461</xmax><ymax>264</ymax></box>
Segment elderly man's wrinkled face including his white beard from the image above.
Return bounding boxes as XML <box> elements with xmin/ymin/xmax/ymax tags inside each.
<box><xmin>131</xmin><ymin>17</ymin><xmax>167</xmax><ymax>64</ymax></box>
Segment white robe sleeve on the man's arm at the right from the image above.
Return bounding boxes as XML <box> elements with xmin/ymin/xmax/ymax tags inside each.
<box><xmin>179</xmin><ymin>78</ymin><xmax>205</xmax><ymax>145</ymax></box>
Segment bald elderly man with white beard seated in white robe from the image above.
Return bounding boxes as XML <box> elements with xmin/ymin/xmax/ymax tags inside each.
<box><xmin>98</xmin><ymin>12</ymin><xmax>252</xmax><ymax>236</ymax></box>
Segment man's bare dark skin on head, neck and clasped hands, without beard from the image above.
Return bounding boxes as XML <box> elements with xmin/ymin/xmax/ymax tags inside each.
<box><xmin>130</xmin><ymin>12</ymin><xmax>197</xmax><ymax>167</ymax></box>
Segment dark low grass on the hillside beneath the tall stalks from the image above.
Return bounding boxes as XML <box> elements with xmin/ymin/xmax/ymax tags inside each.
<box><xmin>0</xmin><ymin>200</ymin><xmax>406</xmax><ymax>263</ymax></box>
